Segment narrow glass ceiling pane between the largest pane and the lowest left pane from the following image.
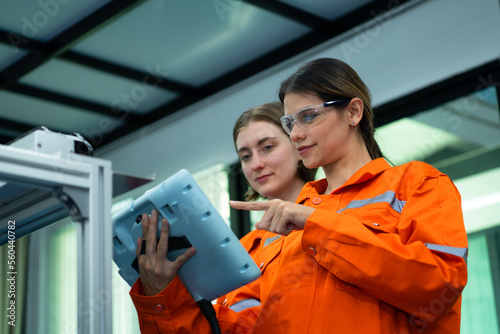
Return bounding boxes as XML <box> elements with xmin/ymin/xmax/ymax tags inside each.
<box><xmin>19</xmin><ymin>59</ymin><xmax>178</xmax><ymax>114</ymax></box>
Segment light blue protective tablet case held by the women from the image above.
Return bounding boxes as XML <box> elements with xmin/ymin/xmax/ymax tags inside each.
<box><xmin>113</xmin><ymin>169</ymin><xmax>260</xmax><ymax>301</ymax></box>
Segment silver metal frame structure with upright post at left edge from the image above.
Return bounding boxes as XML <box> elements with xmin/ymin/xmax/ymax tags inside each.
<box><xmin>0</xmin><ymin>145</ymin><xmax>112</xmax><ymax>333</ymax></box>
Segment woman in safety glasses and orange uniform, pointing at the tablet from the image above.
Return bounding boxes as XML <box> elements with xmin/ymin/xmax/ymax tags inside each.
<box><xmin>231</xmin><ymin>59</ymin><xmax>467</xmax><ymax>334</ymax></box>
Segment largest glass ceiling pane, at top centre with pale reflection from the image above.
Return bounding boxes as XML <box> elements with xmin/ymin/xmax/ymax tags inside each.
<box><xmin>73</xmin><ymin>0</ymin><xmax>311</xmax><ymax>86</ymax></box>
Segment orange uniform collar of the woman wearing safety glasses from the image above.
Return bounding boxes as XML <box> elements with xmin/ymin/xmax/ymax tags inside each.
<box><xmin>296</xmin><ymin>158</ymin><xmax>391</xmax><ymax>203</ymax></box>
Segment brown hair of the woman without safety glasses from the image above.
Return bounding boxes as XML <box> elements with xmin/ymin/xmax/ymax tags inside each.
<box><xmin>233</xmin><ymin>101</ymin><xmax>317</xmax><ymax>201</ymax></box>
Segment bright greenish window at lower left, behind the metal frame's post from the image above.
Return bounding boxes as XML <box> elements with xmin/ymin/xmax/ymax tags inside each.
<box><xmin>19</xmin><ymin>219</ymin><xmax>81</xmax><ymax>334</ymax></box>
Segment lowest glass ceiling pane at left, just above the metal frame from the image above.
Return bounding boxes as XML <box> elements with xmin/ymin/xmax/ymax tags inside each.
<box><xmin>0</xmin><ymin>91</ymin><xmax>123</xmax><ymax>138</ymax></box>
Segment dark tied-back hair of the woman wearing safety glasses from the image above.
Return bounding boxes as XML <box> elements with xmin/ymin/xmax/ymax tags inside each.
<box><xmin>279</xmin><ymin>58</ymin><xmax>383</xmax><ymax>159</ymax></box>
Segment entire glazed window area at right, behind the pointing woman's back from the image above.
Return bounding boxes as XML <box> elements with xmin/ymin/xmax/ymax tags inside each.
<box><xmin>376</xmin><ymin>86</ymin><xmax>500</xmax><ymax>334</ymax></box>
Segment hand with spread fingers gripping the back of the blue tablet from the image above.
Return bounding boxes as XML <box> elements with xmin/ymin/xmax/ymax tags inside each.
<box><xmin>136</xmin><ymin>210</ymin><xmax>196</xmax><ymax>296</ymax></box>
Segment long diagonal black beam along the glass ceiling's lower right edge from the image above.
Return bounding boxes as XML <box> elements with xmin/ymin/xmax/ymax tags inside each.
<box><xmin>94</xmin><ymin>0</ymin><xmax>418</xmax><ymax>146</ymax></box>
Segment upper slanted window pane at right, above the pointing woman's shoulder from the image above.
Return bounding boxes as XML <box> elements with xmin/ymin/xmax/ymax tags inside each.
<box><xmin>376</xmin><ymin>86</ymin><xmax>500</xmax><ymax>170</ymax></box>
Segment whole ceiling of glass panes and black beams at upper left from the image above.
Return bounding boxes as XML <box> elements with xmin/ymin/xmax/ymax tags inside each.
<box><xmin>0</xmin><ymin>0</ymin><xmax>414</xmax><ymax>147</ymax></box>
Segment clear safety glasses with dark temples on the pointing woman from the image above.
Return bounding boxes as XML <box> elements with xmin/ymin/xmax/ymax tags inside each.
<box><xmin>281</xmin><ymin>100</ymin><xmax>350</xmax><ymax>135</ymax></box>
